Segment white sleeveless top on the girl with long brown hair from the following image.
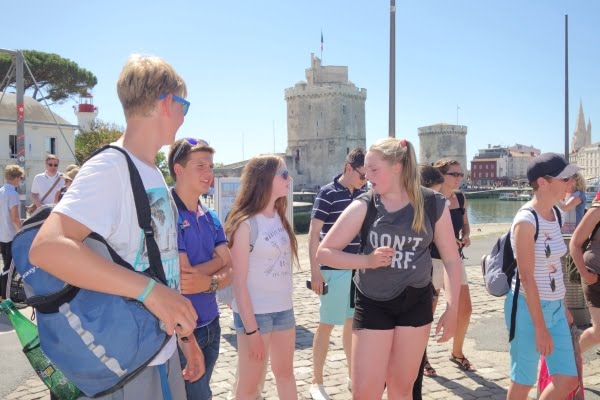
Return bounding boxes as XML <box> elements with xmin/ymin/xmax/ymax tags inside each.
<box><xmin>231</xmin><ymin>214</ymin><xmax>293</xmax><ymax>314</ymax></box>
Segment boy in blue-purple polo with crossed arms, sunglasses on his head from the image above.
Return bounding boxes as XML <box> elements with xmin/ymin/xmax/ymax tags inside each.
<box><xmin>168</xmin><ymin>138</ymin><xmax>232</xmax><ymax>400</ymax></box>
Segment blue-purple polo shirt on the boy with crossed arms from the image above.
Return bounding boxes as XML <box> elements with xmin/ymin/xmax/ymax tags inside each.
<box><xmin>172</xmin><ymin>190</ymin><xmax>227</xmax><ymax>327</ymax></box>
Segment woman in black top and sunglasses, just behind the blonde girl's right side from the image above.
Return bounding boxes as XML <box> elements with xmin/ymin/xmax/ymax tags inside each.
<box><xmin>426</xmin><ymin>159</ymin><xmax>475</xmax><ymax>376</ymax></box>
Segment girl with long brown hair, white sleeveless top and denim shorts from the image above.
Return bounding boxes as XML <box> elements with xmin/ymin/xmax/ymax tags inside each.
<box><xmin>225</xmin><ymin>156</ymin><xmax>298</xmax><ymax>400</ymax></box>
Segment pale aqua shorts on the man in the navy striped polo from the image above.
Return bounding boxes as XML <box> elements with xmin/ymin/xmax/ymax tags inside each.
<box><xmin>319</xmin><ymin>269</ymin><xmax>354</xmax><ymax>325</ymax></box>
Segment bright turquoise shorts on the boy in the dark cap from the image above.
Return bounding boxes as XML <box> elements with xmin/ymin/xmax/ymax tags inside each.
<box><xmin>504</xmin><ymin>290</ymin><xmax>577</xmax><ymax>386</ymax></box>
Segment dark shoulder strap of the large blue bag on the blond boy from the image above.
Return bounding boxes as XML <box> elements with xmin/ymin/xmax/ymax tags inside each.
<box><xmin>90</xmin><ymin>144</ymin><xmax>168</xmax><ymax>286</ymax></box>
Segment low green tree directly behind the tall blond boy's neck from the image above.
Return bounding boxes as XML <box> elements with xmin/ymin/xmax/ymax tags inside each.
<box><xmin>75</xmin><ymin>120</ymin><xmax>173</xmax><ymax>185</ymax></box>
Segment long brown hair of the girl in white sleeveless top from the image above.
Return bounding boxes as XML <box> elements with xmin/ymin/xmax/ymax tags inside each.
<box><xmin>225</xmin><ymin>155</ymin><xmax>300</xmax><ymax>265</ymax></box>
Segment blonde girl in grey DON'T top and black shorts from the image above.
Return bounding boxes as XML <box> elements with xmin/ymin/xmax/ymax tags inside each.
<box><xmin>317</xmin><ymin>138</ymin><xmax>460</xmax><ymax>400</ymax></box>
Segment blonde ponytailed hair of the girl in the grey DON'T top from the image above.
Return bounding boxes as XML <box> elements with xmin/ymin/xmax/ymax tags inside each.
<box><xmin>369</xmin><ymin>138</ymin><xmax>427</xmax><ymax>232</ymax></box>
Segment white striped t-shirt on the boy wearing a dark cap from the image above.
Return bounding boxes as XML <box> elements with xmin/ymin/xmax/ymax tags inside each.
<box><xmin>510</xmin><ymin>208</ymin><xmax>567</xmax><ymax>300</ymax></box>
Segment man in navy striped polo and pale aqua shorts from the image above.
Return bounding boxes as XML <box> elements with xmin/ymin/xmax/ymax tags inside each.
<box><xmin>308</xmin><ymin>149</ymin><xmax>367</xmax><ymax>400</ymax></box>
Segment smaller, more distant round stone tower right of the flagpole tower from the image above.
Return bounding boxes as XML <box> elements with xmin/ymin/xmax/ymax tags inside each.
<box><xmin>419</xmin><ymin>123</ymin><xmax>468</xmax><ymax>172</ymax></box>
